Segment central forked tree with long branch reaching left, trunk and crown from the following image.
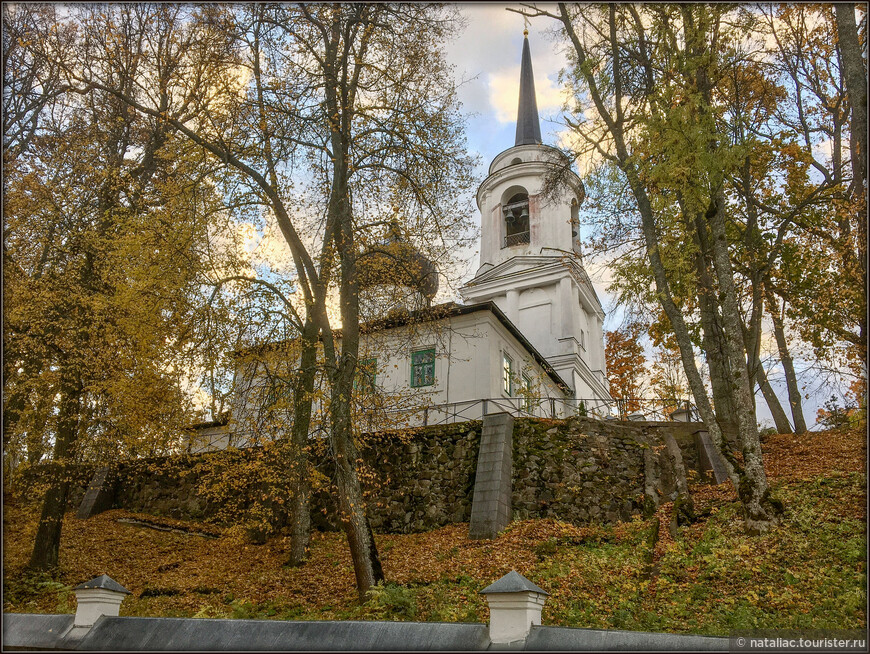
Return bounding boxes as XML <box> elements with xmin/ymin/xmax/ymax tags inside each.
<box><xmin>65</xmin><ymin>4</ymin><xmax>471</xmax><ymax>595</ymax></box>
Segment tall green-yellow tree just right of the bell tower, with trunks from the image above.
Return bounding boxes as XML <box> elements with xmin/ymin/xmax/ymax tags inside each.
<box><xmin>525</xmin><ymin>4</ymin><xmax>781</xmax><ymax>532</ymax></box>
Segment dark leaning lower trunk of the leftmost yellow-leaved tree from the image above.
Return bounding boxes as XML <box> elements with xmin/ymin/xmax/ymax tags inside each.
<box><xmin>29</xmin><ymin>376</ymin><xmax>81</xmax><ymax>570</ymax></box>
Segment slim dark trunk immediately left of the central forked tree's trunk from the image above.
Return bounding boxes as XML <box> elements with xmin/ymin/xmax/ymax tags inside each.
<box><xmin>287</xmin><ymin>318</ymin><xmax>317</xmax><ymax>566</ymax></box>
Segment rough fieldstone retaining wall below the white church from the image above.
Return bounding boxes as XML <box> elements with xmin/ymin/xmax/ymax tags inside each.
<box><xmin>17</xmin><ymin>418</ymin><xmax>712</xmax><ymax>533</ymax></box>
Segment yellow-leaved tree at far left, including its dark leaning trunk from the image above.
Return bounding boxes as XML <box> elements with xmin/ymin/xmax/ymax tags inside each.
<box><xmin>4</xmin><ymin>3</ymin><xmax>245</xmax><ymax>569</ymax></box>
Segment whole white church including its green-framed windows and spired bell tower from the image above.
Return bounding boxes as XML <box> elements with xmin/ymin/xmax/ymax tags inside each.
<box><xmin>193</xmin><ymin>37</ymin><xmax>613</xmax><ymax>451</ymax></box>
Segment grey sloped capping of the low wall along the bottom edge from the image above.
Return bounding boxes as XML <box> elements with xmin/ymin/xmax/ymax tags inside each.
<box><xmin>3</xmin><ymin>616</ymin><xmax>729</xmax><ymax>651</ymax></box>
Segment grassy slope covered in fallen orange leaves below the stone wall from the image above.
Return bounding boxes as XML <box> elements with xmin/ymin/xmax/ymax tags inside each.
<box><xmin>3</xmin><ymin>429</ymin><xmax>866</xmax><ymax>634</ymax></box>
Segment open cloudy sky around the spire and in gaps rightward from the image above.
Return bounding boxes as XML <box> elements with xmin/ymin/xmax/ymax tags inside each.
<box><xmin>445</xmin><ymin>3</ymin><xmax>832</xmax><ymax>426</ymax></box>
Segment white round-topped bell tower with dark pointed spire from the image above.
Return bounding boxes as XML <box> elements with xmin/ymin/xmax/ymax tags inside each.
<box><xmin>459</xmin><ymin>31</ymin><xmax>610</xmax><ymax>400</ymax></box>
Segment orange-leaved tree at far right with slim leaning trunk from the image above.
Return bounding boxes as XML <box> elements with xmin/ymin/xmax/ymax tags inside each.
<box><xmin>753</xmin><ymin>5</ymin><xmax>866</xmax><ymax>433</ymax></box>
